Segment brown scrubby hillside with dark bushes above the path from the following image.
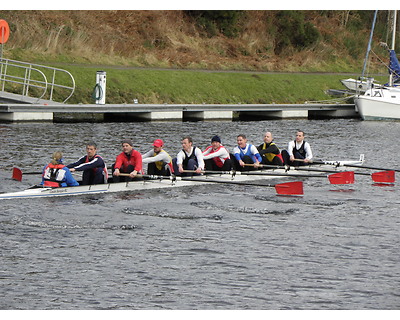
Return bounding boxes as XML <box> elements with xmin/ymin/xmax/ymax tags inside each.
<box><xmin>0</xmin><ymin>10</ymin><xmax>394</xmax><ymax>72</ymax></box>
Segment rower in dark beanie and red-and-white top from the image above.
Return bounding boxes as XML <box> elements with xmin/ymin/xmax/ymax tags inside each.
<box><xmin>203</xmin><ymin>136</ymin><xmax>232</xmax><ymax>171</ymax></box>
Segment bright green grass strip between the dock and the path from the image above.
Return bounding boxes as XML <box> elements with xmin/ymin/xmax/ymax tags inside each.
<box><xmin>47</xmin><ymin>66</ymin><xmax>388</xmax><ymax>104</ymax></box>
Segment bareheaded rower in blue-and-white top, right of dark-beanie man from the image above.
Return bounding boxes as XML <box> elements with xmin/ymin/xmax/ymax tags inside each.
<box><xmin>232</xmin><ymin>134</ymin><xmax>262</xmax><ymax>171</ymax></box>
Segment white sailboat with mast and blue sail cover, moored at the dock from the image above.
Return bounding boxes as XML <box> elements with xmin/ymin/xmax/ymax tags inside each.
<box><xmin>354</xmin><ymin>11</ymin><xmax>400</xmax><ymax>120</ymax></box>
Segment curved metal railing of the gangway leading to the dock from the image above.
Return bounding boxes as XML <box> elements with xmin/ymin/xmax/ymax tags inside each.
<box><xmin>0</xmin><ymin>59</ymin><xmax>75</xmax><ymax>103</ymax></box>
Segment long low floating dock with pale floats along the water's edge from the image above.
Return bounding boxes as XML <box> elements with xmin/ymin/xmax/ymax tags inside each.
<box><xmin>0</xmin><ymin>102</ymin><xmax>360</xmax><ymax>122</ymax></box>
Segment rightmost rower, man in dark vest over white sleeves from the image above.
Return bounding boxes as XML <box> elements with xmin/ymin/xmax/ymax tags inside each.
<box><xmin>282</xmin><ymin>130</ymin><xmax>313</xmax><ymax>166</ymax></box>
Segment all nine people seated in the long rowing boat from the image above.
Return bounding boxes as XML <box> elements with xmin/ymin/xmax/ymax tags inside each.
<box><xmin>42</xmin><ymin>130</ymin><xmax>312</xmax><ymax>187</ymax></box>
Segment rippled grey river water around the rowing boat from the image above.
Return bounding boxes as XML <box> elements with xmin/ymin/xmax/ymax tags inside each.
<box><xmin>0</xmin><ymin>119</ymin><xmax>400</xmax><ymax>310</ymax></box>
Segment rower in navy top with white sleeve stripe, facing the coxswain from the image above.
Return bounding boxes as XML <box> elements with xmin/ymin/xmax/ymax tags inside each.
<box><xmin>67</xmin><ymin>142</ymin><xmax>108</xmax><ymax>185</ymax></box>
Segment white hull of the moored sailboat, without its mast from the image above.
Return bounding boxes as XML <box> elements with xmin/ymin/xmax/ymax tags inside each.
<box><xmin>354</xmin><ymin>88</ymin><xmax>400</xmax><ymax>120</ymax></box>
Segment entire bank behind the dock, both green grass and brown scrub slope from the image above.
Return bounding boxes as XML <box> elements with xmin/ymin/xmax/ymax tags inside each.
<box><xmin>0</xmin><ymin>10</ymin><xmax>394</xmax><ymax>104</ymax></box>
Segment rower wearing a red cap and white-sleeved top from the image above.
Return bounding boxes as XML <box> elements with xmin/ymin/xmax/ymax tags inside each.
<box><xmin>142</xmin><ymin>139</ymin><xmax>173</xmax><ymax>176</ymax></box>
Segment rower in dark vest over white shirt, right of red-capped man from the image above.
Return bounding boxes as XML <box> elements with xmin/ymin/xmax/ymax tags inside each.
<box><xmin>172</xmin><ymin>137</ymin><xmax>204</xmax><ymax>176</ymax></box>
